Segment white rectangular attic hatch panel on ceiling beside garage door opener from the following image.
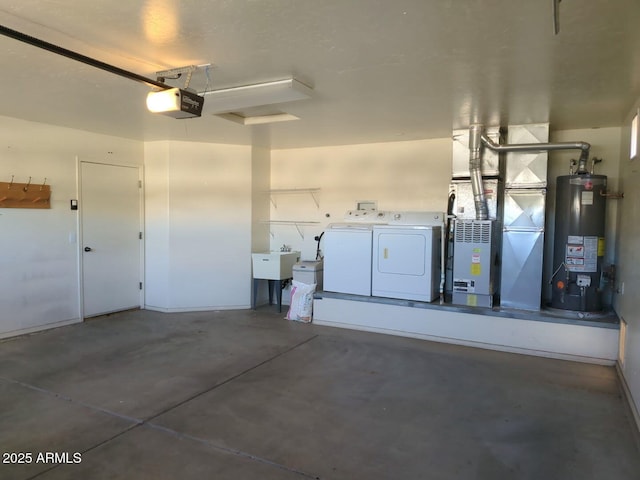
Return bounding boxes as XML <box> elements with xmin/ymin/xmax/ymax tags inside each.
<box><xmin>200</xmin><ymin>78</ymin><xmax>313</xmax><ymax>114</ymax></box>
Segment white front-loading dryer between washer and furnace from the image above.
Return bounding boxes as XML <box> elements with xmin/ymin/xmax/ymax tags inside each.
<box><xmin>371</xmin><ymin>212</ymin><xmax>444</xmax><ymax>302</ymax></box>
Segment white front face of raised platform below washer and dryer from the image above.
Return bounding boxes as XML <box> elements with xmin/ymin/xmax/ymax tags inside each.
<box><xmin>313</xmin><ymin>296</ymin><xmax>619</xmax><ymax>366</ymax></box>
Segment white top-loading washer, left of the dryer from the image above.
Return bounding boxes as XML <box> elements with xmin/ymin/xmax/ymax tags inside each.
<box><xmin>323</xmin><ymin>210</ymin><xmax>389</xmax><ymax>296</ymax></box>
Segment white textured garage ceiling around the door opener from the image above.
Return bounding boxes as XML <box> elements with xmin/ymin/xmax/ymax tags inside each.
<box><xmin>0</xmin><ymin>0</ymin><xmax>640</xmax><ymax>148</ymax></box>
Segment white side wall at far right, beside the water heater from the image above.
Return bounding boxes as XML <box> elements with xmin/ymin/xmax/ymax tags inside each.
<box><xmin>615</xmin><ymin>99</ymin><xmax>640</xmax><ymax>426</ymax></box>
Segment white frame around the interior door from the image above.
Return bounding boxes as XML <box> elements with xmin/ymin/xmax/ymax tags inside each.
<box><xmin>76</xmin><ymin>155</ymin><xmax>146</xmax><ymax>321</ymax></box>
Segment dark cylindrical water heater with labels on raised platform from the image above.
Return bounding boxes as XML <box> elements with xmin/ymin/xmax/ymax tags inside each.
<box><xmin>551</xmin><ymin>173</ymin><xmax>607</xmax><ymax>312</ymax></box>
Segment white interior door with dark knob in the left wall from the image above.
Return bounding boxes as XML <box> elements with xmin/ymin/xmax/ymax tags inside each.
<box><xmin>80</xmin><ymin>162</ymin><xmax>141</xmax><ymax>317</ymax></box>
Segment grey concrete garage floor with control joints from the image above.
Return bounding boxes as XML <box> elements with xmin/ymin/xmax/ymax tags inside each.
<box><xmin>0</xmin><ymin>307</ymin><xmax>640</xmax><ymax>480</ymax></box>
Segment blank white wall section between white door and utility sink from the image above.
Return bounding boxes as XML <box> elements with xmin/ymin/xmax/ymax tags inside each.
<box><xmin>145</xmin><ymin>142</ymin><xmax>252</xmax><ymax>311</ymax></box>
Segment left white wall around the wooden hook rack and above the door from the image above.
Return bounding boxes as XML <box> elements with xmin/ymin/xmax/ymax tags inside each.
<box><xmin>0</xmin><ymin>117</ymin><xmax>143</xmax><ymax>337</ymax></box>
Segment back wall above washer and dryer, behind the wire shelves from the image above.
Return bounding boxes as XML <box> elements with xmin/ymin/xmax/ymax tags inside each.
<box><xmin>271</xmin><ymin>138</ymin><xmax>452</xmax><ymax>260</ymax></box>
